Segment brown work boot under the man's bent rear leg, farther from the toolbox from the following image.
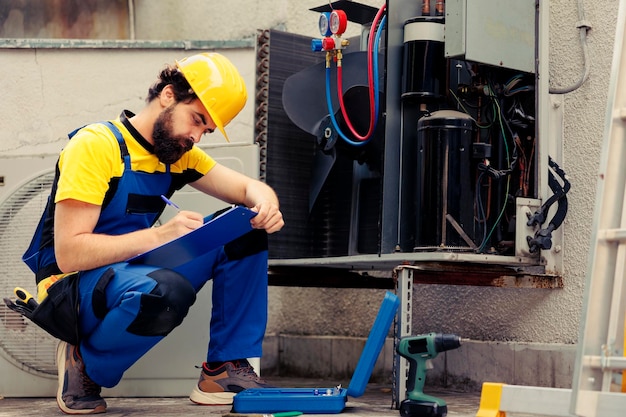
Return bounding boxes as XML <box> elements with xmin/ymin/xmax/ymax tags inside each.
<box><xmin>57</xmin><ymin>342</ymin><xmax>107</xmax><ymax>414</ymax></box>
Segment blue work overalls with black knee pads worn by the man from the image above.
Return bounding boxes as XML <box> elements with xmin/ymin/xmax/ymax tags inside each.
<box><xmin>21</xmin><ymin>122</ymin><xmax>267</xmax><ymax>388</ymax></box>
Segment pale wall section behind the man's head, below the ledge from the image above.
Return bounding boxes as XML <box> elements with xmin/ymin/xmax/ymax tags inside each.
<box><xmin>0</xmin><ymin>48</ymin><xmax>254</xmax><ymax>155</ymax></box>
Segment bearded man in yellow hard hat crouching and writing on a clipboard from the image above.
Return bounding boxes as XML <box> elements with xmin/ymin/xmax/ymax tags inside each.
<box><xmin>24</xmin><ymin>53</ymin><xmax>284</xmax><ymax>414</ymax></box>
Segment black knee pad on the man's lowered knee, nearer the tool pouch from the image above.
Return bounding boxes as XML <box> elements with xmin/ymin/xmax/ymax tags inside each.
<box><xmin>126</xmin><ymin>269</ymin><xmax>196</xmax><ymax>336</ymax></box>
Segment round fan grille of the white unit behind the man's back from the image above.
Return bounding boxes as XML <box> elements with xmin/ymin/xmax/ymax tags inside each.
<box><xmin>0</xmin><ymin>171</ymin><xmax>57</xmax><ymax>375</ymax></box>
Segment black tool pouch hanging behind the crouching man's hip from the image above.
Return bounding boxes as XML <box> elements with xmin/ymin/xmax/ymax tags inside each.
<box><xmin>4</xmin><ymin>272</ymin><xmax>80</xmax><ymax>345</ymax></box>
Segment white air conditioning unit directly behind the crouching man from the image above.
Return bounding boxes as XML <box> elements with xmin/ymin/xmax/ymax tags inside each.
<box><xmin>0</xmin><ymin>145</ymin><xmax>259</xmax><ymax>397</ymax></box>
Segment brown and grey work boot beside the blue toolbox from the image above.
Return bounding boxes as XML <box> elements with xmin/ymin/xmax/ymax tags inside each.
<box><xmin>189</xmin><ymin>359</ymin><xmax>270</xmax><ymax>405</ymax></box>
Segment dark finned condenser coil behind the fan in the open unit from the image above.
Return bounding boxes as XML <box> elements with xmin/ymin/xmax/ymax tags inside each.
<box><xmin>255</xmin><ymin>30</ymin><xmax>384</xmax><ymax>259</ymax></box>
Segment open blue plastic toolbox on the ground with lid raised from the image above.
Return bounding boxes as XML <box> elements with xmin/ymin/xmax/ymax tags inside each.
<box><xmin>233</xmin><ymin>291</ymin><xmax>400</xmax><ymax>414</ymax></box>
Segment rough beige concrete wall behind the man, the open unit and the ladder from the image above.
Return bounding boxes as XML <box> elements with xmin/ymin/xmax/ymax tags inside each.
<box><xmin>0</xmin><ymin>0</ymin><xmax>619</xmax><ymax>386</ymax></box>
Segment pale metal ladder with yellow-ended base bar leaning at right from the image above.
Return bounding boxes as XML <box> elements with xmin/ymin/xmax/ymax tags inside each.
<box><xmin>476</xmin><ymin>1</ymin><xmax>626</xmax><ymax>417</ymax></box>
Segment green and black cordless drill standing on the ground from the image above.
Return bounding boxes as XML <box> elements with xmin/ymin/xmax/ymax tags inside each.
<box><xmin>396</xmin><ymin>333</ymin><xmax>461</xmax><ymax>417</ymax></box>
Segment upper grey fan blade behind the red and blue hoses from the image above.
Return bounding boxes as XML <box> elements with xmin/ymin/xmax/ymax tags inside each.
<box><xmin>283</xmin><ymin>51</ymin><xmax>376</xmax><ymax>135</ymax></box>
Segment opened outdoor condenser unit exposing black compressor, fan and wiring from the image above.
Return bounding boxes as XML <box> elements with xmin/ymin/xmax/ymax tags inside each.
<box><xmin>255</xmin><ymin>0</ymin><xmax>569</xmax><ymax>275</ymax></box>
